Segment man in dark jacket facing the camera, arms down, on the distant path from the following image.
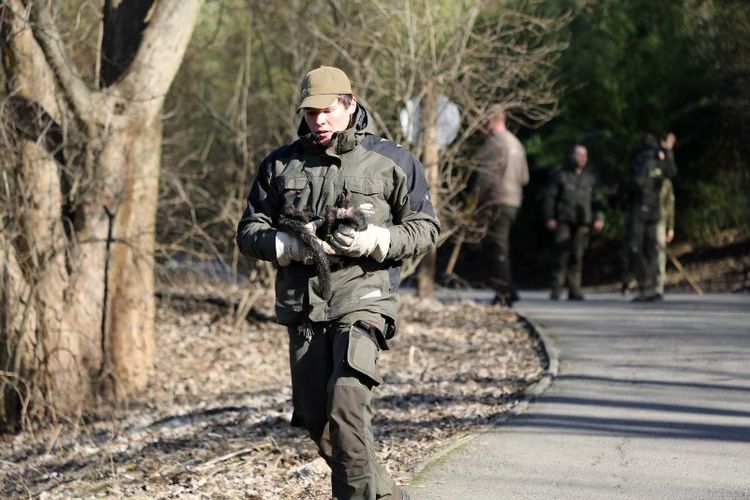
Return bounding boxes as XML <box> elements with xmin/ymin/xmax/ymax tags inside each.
<box><xmin>543</xmin><ymin>144</ymin><xmax>604</xmax><ymax>300</ymax></box>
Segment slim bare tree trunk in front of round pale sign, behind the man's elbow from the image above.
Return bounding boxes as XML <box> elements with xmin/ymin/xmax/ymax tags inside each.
<box><xmin>417</xmin><ymin>85</ymin><xmax>440</xmax><ymax>298</ymax></box>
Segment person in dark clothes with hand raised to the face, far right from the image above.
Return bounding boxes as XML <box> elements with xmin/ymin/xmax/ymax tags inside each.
<box><xmin>628</xmin><ymin>133</ymin><xmax>677</xmax><ymax>302</ymax></box>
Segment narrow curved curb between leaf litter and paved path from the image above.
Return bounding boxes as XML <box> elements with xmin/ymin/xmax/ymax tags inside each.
<box><xmin>409</xmin><ymin>311</ymin><xmax>560</xmax><ymax>488</ymax></box>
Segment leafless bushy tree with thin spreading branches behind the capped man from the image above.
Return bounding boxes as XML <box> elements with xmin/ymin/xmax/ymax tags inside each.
<box><xmin>308</xmin><ymin>0</ymin><xmax>570</xmax><ymax>296</ymax></box>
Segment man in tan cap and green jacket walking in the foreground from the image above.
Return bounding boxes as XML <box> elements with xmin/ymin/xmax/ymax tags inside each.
<box><xmin>237</xmin><ymin>66</ymin><xmax>440</xmax><ymax>500</ymax></box>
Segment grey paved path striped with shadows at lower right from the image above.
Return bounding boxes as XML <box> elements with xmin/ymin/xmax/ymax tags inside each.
<box><xmin>411</xmin><ymin>293</ymin><xmax>750</xmax><ymax>500</ymax></box>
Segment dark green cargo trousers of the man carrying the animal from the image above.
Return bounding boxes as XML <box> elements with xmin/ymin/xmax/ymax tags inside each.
<box><xmin>288</xmin><ymin>312</ymin><xmax>401</xmax><ymax>500</ymax></box>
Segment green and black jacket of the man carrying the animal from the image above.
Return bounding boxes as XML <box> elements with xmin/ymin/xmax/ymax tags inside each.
<box><xmin>237</xmin><ymin>106</ymin><xmax>440</xmax><ymax>330</ymax></box>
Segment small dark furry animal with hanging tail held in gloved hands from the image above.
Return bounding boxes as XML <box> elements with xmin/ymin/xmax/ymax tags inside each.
<box><xmin>276</xmin><ymin>188</ymin><xmax>367</xmax><ymax>300</ymax></box>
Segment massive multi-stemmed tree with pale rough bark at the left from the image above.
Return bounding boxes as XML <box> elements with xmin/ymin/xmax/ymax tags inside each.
<box><xmin>0</xmin><ymin>0</ymin><xmax>202</xmax><ymax>428</ymax></box>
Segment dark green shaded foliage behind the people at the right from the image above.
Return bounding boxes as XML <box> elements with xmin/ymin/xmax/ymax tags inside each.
<box><xmin>506</xmin><ymin>0</ymin><xmax>750</xmax><ymax>284</ymax></box>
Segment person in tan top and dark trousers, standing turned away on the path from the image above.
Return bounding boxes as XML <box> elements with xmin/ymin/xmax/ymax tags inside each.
<box><xmin>474</xmin><ymin>104</ymin><xmax>529</xmax><ymax>306</ymax></box>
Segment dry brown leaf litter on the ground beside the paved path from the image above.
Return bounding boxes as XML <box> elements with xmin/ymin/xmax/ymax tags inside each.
<box><xmin>0</xmin><ymin>295</ymin><xmax>545</xmax><ymax>499</ymax></box>
